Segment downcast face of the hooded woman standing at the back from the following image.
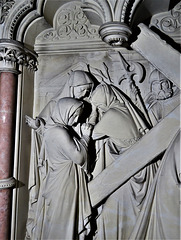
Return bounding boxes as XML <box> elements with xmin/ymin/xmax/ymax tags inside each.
<box><xmin>73</xmin><ymin>84</ymin><xmax>92</xmax><ymax>99</ymax></box>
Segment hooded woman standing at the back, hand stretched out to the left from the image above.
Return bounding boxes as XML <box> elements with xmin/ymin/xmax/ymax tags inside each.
<box><xmin>26</xmin><ymin>70</ymin><xmax>94</xmax><ymax>236</ymax></box>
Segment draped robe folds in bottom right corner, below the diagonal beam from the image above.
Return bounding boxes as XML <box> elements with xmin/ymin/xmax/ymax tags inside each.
<box><xmin>129</xmin><ymin>130</ymin><xmax>181</xmax><ymax>240</ymax></box>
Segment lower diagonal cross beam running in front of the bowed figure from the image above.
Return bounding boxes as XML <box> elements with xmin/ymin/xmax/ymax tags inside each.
<box><xmin>88</xmin><ymin>106</ymin><xmax>180</xmax><ymax>207</ymax></box>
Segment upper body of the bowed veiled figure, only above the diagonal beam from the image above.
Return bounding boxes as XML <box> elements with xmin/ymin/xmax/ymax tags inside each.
<box><xmin>91</xmin><ymin>83</ymin><xmax>148</xmax><ymax>177</ymax></box>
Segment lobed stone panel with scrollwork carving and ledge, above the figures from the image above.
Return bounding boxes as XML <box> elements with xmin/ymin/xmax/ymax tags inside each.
<box><xmin>35</xmin><ymin>2</ymin><xmax>110</xmax><ymax>52</ymax></box>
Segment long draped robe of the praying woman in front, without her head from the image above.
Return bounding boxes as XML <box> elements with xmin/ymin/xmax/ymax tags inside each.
<box><xmin>34</xmin><ymin>126</ymin><xmax>91</xmax><ymax>240</ymax></box>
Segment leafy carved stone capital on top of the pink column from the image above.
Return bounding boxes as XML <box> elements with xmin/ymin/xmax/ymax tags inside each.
<box><xmin>0</xmin><ymin>39</ymin><xmax>37</xmax><ymax>74</ymax></box>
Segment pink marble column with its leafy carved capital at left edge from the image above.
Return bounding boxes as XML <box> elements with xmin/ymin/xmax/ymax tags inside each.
<box><xmin>0</xmin><ymin>39</ymin><xmax>36</xmax><ymax>240</ymax></box>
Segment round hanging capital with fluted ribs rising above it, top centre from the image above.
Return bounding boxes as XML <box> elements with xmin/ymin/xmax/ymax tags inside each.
<box><xmin>83</xmin><ymin>0</ymin><xmax>141</xmax><ymax>46</ymax></box>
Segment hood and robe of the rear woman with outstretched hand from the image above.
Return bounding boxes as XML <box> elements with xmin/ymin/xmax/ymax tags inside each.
<box><xmin>26</xmin><ymin>70</ymin><xmax>94</xmax><ymax>236</ymax></box>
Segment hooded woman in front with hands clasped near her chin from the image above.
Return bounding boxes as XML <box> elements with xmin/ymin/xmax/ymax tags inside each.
<box><xmin>33</xmin><ymin>98</ymin><xmax>91</xmax><ymax>240</ymax></box>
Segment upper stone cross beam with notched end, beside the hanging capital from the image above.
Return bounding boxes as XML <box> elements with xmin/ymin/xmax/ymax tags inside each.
<box><xmin>131</xmin><ymin>23</ymin><xmax>181</xmax><ymax>88</ymax></box>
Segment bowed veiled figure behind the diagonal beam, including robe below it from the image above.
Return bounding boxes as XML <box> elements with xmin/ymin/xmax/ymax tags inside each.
<box><xmin>92</xmin><ymin>84</ymin><xmax>157</xmax><ymax>240</ymax></box>
